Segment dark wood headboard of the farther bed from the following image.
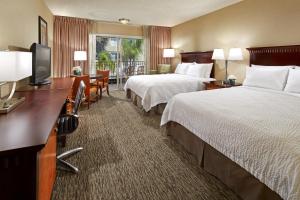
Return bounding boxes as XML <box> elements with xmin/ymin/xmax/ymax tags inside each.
<box><xmin>180</xmin><ymin>51</ymin><xmax>215</xmax><ymax>78</ymax></box>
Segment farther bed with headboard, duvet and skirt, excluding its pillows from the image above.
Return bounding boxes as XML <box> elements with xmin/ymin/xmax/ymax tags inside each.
<box><xmin>124</xmin><ymin>51</ymin><xmax>215</xmax><ymax>113</ymax></box>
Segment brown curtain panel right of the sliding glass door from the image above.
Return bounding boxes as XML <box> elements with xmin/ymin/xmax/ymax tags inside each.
<box><xmin>149</xmin><ymin>26</ymin><xmax>171</xmax><ymax>70</ymax></box>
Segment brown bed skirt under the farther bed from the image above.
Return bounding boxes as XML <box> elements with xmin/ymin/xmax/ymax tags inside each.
<box><xmin>126</xmin><ymin>89</ymin><xmax>167</xmax><ymax>115</ymax></box>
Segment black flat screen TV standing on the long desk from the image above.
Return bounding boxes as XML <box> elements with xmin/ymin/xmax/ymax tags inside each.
<box><xmin>30</xmin><ymin>43</ymin><xmax>51</xmax><ymax>85</ymax></box>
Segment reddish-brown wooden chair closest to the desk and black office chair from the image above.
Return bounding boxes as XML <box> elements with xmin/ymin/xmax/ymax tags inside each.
<box><xmin>72</xmin><ymin>75</ymin><xmax>91</xmax><ymax>109</ymax></box>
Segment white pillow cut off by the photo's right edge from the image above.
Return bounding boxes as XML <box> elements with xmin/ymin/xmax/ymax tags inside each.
<box><xmin>284</xmin><ymin>67</ymin><xmax>300</xmax><ymax>93</ymax></box>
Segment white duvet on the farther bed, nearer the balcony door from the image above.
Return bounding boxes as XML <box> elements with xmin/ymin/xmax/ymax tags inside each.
<box><xmin>124</xmin><ymin>74</ymin><xmax>215</xmax><ymax>111</ymax></box>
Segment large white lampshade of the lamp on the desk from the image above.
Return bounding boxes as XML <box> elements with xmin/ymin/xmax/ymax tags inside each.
<box><xmin>0</xmin><ymin>51</ymin><xmax>32</xmax><ymax>82</ymax></box>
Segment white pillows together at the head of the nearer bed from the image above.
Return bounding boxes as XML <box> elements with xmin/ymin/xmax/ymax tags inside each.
<box><xmin>243</xmin><ymin>65</ymin><xmax>300</xmax><ymax>93</ymax></box>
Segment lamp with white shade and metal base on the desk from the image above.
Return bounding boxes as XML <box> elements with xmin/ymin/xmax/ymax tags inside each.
<box><xmin>0</xmin><ymin>51</ymin><xmax>32</xmax><ymax>113</ymax></box>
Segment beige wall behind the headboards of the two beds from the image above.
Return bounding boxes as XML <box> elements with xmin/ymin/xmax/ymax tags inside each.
<box><xmin>172</xmin><ymin>0</ymin><xmax>300</xmax><ymax>81</ymax></box>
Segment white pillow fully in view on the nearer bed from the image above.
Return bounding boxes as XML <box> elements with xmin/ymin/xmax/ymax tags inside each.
<box><xmin>243</xmin><ymin>66</ymin><xmax>289</xmax><ymax>91</ymax></box>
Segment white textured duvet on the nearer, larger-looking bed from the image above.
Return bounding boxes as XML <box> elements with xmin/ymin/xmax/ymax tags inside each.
<box><xmin>161</xmin><ymin>87</ymin><xmax>300</xmax><ymax>200</ymax></box>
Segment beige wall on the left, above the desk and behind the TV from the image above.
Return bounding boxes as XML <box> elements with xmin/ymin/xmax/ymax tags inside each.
<box><xmin>0</xmin><ymin>0</ymin><xmax>53</xmax><ymax>96</ymax></box>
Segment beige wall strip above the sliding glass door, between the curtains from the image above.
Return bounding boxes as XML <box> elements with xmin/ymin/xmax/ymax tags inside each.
<box><xmin>92</xmin><ymin>21</ymin><xmax>143</xmax><ymax>36</ymax></box>
